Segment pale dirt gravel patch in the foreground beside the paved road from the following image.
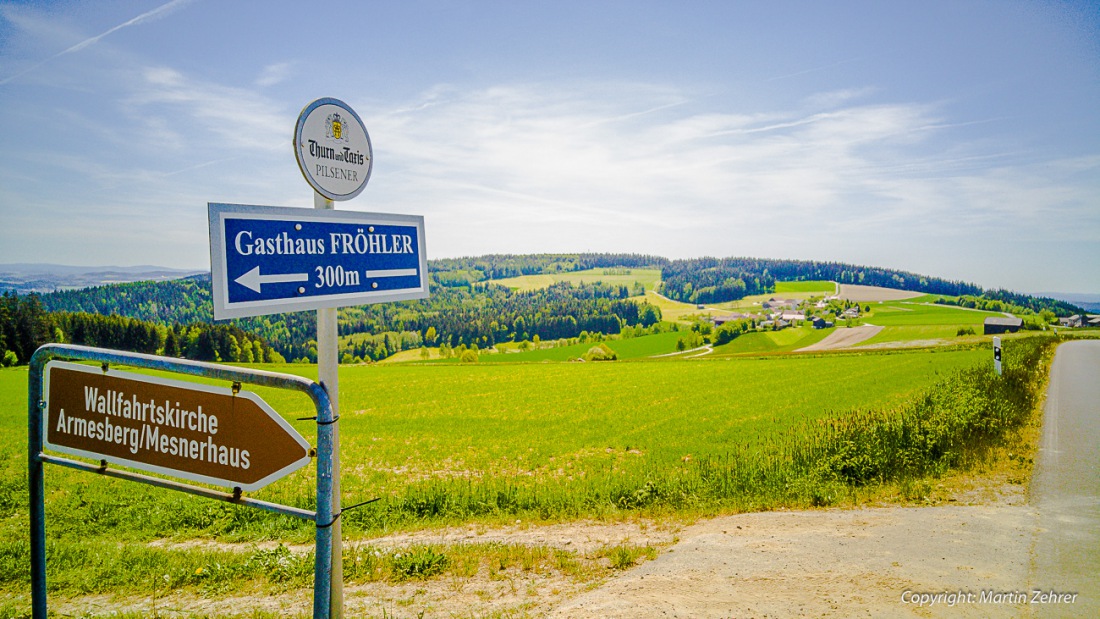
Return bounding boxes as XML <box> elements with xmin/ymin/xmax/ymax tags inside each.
<box><xmin>549</xmin><ymin>505</ymin><xmax>1038</xmax><ymax>618</ymax></box>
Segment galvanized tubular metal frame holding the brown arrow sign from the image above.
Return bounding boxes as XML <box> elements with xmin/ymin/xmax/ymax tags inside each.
<box><xmin>28</xmin><ymin>344</ymin><xmax>340</xmax><ymax>619</ymax></box>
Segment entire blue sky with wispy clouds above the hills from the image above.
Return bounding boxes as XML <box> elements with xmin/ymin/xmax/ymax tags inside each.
<box><xmin>0</xmin><ymin>0</ymin><xmax>1100</xmax><ymax>292</ymax></box>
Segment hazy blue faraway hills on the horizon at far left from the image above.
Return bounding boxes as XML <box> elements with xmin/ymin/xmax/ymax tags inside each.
<box><xmin>0</xmin><ymin>263</ymin><xmax>209</xmax><ymax>295</ymax></box>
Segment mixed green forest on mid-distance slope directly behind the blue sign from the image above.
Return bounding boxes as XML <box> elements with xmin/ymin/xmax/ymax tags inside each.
<box><xmin>41</xmin><ymin>272</ymin><xmax>661</xmax><ymax>362</ymax></box>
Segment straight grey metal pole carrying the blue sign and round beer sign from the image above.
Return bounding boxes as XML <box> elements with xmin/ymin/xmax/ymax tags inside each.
<box><xmin>314</xmin><ymin>191</ymin><xmax>343</xmax><ymax>619</ymax></box>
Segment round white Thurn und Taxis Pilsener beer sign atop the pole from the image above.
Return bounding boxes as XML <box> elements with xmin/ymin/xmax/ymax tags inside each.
<box><xmin>294</xmin><ymin>98</ymin><xmax>374</xmax><ymax>200</ymax></box>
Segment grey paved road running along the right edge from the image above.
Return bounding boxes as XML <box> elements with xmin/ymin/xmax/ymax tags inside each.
<box><xmin>1030</xmin><ymin>341</ymin><xmax>1100</xmax><ymax>617</ymax></box>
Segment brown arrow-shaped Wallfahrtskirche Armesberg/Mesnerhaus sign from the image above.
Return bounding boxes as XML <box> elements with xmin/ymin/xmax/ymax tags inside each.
<box><xmin>43</xmin><ymin>361</ymin><xmax>309</xmax><ymax>490</ymax></box>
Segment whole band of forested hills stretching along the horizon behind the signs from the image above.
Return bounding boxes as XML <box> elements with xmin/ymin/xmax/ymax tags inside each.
<box><xmin>0</xmin><ymin>254</ymin><xmax>1087</xmax><ymax>362</ymax></box>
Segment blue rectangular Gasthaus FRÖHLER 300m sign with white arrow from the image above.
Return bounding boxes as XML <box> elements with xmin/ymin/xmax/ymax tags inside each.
<box><xmin>208</xmin><ymin>203</ymin><xmax>428</xmax><ymax>320</ymax></box>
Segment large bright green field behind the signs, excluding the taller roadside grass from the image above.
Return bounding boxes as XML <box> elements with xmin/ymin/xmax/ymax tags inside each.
<box><xmin>0</xmin><ymin>347</ymin><xmax>982</xmax><ymax>541</ymax></box>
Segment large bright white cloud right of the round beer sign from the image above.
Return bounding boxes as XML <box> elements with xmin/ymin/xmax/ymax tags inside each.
<box><xmin>364</xmin><ymin>85</ymin><xmax>1100</xmax><ymax>278</ymax></box>
